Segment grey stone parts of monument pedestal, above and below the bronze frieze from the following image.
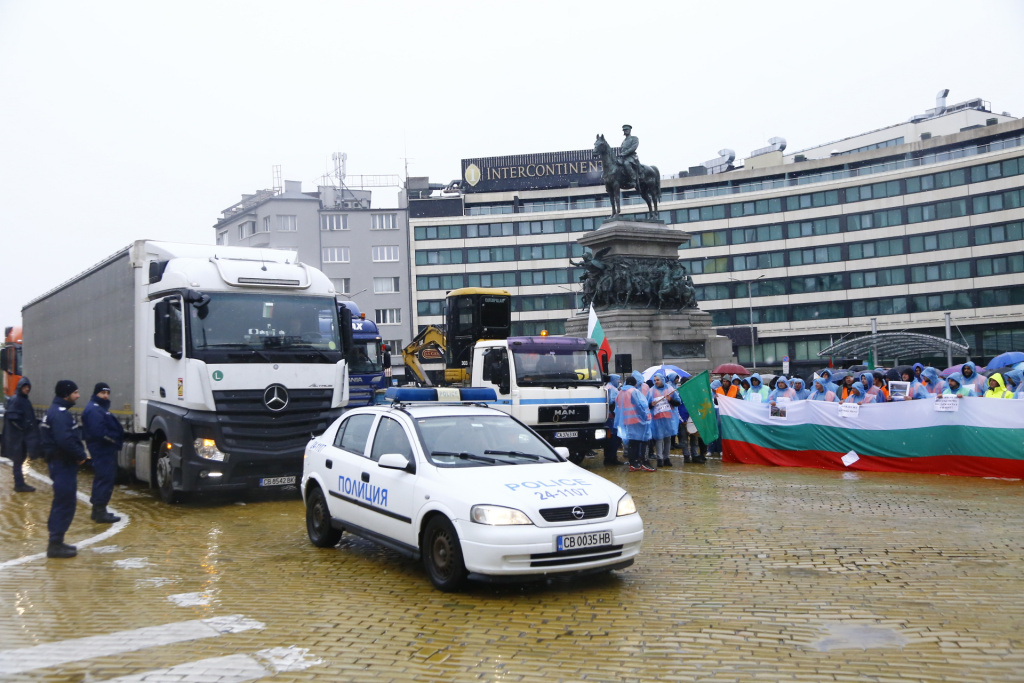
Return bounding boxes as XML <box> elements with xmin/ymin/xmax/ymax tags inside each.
<box><xmin>565</xmin><ymin>220</ymin><xmax>735</xmax><ymax>375</ymax></box>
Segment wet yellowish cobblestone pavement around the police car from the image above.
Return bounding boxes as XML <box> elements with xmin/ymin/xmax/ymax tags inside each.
<box><xmin>0</xmin><ymin>459</ymin><xmax>1024</xmax><ymax>683</ymax></box>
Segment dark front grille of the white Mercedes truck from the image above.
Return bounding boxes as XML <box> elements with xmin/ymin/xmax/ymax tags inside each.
<box><xmin>213</xmin><ymin>389</ymin><xmax>341</xmax><ymax>455</ymax></box>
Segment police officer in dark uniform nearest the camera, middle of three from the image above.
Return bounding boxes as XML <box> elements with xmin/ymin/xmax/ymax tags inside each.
<box><xmin>39</xmin><ymin>380</ymin><xmax>88</xmax><ymax>557</ymax></box>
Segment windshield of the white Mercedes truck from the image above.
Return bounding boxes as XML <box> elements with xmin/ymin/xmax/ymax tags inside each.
<box><xmin>188</xmin><ymin>293</ymin><xmax>342</xmax><ymax>364</ymax></box>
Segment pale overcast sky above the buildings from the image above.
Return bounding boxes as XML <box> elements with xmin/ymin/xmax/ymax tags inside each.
<box><xmin>0</xmin><ymin>0</ymin><xmax>1024</xmax><ymax>327</ymax></box>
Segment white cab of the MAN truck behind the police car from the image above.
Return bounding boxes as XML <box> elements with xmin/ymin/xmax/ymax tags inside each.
<box><xmin>470</xmin><ymin>336</ymin><xmax>608</xmax><ymax>463</ymax></box>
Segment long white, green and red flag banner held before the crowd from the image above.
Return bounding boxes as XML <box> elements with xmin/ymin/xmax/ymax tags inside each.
<box><xmin>718</xmin><ymin>396</ymin><xmax>1024</xmax><ymax>479</ymax></box>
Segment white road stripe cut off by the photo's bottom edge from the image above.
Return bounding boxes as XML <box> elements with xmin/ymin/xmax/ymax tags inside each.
<box><xmin>105</xmin><ymin>647</ymin><xmax>324</xmax><ymax>683</ymax></box>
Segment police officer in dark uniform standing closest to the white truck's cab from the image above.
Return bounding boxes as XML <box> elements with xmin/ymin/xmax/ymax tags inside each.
<box><xmin>82</xmin><ymin>382</ymin><xmax>125</xmax><ymax>524</ymax></box>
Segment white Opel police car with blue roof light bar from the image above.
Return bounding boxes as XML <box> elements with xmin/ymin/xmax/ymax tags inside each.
<box><xmin>302</xmin><ymin>387</ymin><xmax>643</xmax><ymax>591</ymax></box>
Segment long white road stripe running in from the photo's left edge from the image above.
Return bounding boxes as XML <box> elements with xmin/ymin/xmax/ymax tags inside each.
<box><xmin>0</xmin><ymin>614</ymin><xmax>264</xmax><ymax>676</ymax></box>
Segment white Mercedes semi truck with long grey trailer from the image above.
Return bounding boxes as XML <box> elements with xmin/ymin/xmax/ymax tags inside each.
<box><xmin>22</xmin><ymin>240</ymin><xmax>351</xmax><ymax>503</ymax></box>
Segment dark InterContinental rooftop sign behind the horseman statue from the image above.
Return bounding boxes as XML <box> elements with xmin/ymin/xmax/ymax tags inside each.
<box><xmin>462</xmin><ymin>150</ymin><xmax>603</xmax><ymax>193</ymax></box>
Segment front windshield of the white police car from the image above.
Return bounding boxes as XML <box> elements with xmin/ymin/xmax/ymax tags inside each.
<box><xmin>416</xmin><ymin>415</ymin><xmax>559</xmax><ymax>467</ymax></box>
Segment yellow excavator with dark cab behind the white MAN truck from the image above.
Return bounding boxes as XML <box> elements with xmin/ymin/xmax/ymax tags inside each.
<box><xmin>401</xmin><ymin>287</ymin><xmax>512</xmax><ymax>386</ymax></box>
